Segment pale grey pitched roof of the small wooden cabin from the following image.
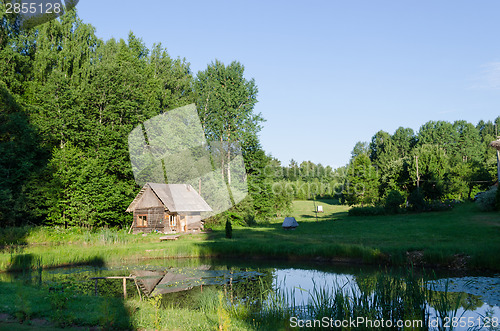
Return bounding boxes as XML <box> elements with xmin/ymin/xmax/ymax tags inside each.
<box><xmin>127</xmin><ymin>183</ymin><xmax>212</xmax><ymax>212</ymax></box>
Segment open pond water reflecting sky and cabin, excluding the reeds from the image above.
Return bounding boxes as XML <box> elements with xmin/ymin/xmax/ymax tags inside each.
<box><xmin>0</xmin><ymin>259</ymin><xmax>500</xmax><ymax>330</ymax></box>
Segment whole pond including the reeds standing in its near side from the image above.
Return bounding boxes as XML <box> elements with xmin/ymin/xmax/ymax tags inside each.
<box><xmin>0</xmin><ymin>259</ymin><xmax>500</xmax><ymax>330</ymax></box>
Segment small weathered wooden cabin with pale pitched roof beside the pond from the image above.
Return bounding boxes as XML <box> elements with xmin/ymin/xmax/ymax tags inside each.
<box><xmin>127</xmin><ymin>183</ymin><xmax>212</xmax><ymax>233</ymax></box>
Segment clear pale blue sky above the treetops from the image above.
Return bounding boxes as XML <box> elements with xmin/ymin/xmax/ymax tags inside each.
<box><xmin>77</xmin><ymin>0</ymin><xmax>500</xmax><ymax>167</ymax></box>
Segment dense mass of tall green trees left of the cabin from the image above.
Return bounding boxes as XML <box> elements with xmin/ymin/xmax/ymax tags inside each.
<box><xmin>0</xmin><ymin>11</ymin><xmax>200</xmax><ymax>228</ymax></box>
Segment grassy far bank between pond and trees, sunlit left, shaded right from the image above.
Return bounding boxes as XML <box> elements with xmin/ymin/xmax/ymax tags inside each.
<box><xmin>0</xmin><ymin>200</ymin><xmax>500</xmax><ymax>271</ymax></box>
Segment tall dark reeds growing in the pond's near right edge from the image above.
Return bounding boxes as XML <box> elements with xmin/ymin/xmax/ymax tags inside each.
<box><xmin>247</xmin><ymin>273</ymin><xmax>468</xmax><ymax>330</ymax></box>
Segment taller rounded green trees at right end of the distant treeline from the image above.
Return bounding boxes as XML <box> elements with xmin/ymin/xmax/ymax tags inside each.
<box><xmin>344</xmin><ymin>121</ymin><xmax>496</xmax><ymax>208</ymax></box>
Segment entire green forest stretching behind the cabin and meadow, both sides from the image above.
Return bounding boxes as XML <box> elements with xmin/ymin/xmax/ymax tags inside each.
<box><xmin>0</xmin><ymin>8</ymin><xmax>500</xmax><ymax>228</ymax></box>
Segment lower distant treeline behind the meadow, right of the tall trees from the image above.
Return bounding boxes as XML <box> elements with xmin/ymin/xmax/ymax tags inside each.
<box><xmin>270</xmin><ymin>116</ymin><xmax>500</xmax><ymax>205</ymax></box>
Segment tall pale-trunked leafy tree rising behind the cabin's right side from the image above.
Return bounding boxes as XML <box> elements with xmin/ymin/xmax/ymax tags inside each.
<box><xmin>194</xmin><ymin>60</ymin><xmax>263</xmax><ymax>184</ymax></box>
